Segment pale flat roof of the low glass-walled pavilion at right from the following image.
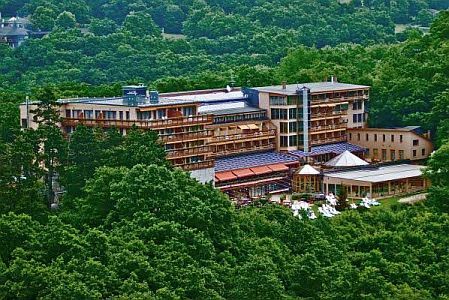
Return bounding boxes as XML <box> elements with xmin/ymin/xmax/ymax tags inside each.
<box><xmin>324</xmin><ymin>164</ymin><xmax>425</xmax><ymax>183</ymax></box>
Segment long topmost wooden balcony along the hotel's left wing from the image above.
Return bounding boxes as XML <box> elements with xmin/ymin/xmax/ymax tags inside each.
<box><xmin>62</xmin><ymin>115</ymin><xmax>213</xmax><ymax>129</ymax></box>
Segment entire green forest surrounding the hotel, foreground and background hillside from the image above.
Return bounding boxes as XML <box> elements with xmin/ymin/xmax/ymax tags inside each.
<box><xmin>0</xmin><ymin>0</ymin><xmax>449</xmax><ymax>300</ymax></box>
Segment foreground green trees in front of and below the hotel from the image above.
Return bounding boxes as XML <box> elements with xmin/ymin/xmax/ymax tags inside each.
<box><xmin>0</xmin><ymin>88</ymin><xmax>449</xmax><ymax>300</ymax></box>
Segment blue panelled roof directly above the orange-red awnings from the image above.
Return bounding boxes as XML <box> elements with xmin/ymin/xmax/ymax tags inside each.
<box><xmin>215</xmin><ymin>152</ymin><xmax>298</xmax><ymax>172</ymax></box>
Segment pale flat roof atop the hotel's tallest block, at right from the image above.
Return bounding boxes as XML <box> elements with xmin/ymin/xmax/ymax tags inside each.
<box><xmin>254</xmin><ymin>82</ymin><xmax>370</xmax><ymax>95</ymax></box>
